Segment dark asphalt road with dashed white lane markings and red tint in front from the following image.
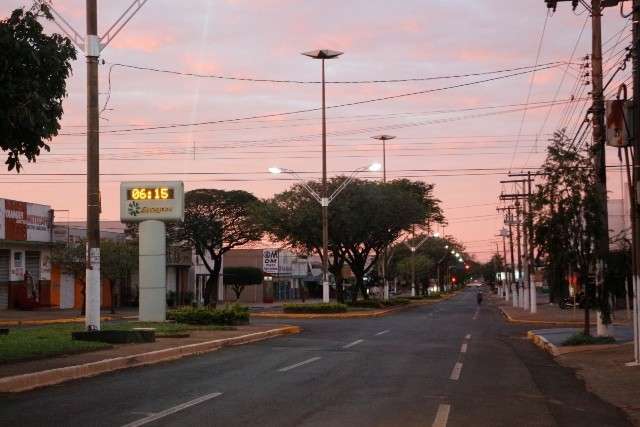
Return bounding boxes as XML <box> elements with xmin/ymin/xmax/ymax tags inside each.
<box><xmin>0</xmin><ymin>290</ymin><xmax>630</xmax><ymax>427</ymax></box>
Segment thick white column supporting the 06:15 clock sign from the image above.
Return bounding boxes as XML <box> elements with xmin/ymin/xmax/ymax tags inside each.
<box><xmin>138</xmin><ymin>220</ymin><xmax>167</xmax><ymax>322</ymax></box>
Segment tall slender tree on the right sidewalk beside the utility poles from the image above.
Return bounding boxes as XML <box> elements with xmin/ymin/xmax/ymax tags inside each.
<box><xmin>530</xmin><ymin>131</ymin><xmax>610</xmax><ymax>335</ymax></box>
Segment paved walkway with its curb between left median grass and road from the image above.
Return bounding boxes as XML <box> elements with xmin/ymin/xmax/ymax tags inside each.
<box><xmin>0</xmin><ymin>325</ymin><xmax>301</xmax><ymax>393</ymax></box>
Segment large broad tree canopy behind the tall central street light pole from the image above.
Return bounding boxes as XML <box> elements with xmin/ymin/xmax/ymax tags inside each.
<box><xmin>261</xmin><ymin>177</ymin><xmax>442</xmax><ymax>296</ymax></box>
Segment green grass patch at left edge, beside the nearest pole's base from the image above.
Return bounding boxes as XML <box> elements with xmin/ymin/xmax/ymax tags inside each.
<box><xmin>0</xmin><ymin>325</ymin><xmax>111</xmax><ymax>364</ymax></box>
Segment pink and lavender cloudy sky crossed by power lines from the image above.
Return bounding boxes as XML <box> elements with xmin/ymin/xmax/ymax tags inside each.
<box><xmin>0</xmin><ymin>0</ymin><xmax>631</xmax><ymax>260</ymax></box>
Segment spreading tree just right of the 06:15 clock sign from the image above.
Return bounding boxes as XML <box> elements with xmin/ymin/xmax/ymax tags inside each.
<box><xmin>168</xmin><ymin>189</ymin><xmax>263</xmax><ymax>306</ymax></box>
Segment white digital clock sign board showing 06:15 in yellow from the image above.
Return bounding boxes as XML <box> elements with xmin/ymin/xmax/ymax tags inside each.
<box><xmin>120</xmin><ymin>181</ymin><xmax>184</xmax><ymax>222</ymax></box>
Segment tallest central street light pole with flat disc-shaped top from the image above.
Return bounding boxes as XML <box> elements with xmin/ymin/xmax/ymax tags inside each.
<box><xmin>303</xmin><ymin>49</ymin><xmax>342</xmax><ymax>303</ymax></box>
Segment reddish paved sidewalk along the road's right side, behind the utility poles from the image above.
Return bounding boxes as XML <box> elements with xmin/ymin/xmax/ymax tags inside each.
<box><xmin>492</xmin><ymin>294</ymin><xmax>631</xmax><ymax>326</ymax></box>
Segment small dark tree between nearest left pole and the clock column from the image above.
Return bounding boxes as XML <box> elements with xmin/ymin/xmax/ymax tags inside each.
<box><xmin>100</xmin><ymin>240</ymin><xmax>139</xmax><ymax>313</ymax></box>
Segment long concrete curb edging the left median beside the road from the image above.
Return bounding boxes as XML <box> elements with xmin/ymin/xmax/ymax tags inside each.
<box><xmin>0</xmin><ymin>326</ymin><xmax>302</xmax><ymax>393</ymax></box>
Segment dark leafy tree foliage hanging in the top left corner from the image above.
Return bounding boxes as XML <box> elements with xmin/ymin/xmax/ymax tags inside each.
<box><xmin>0</xmin><ymin>2</ymin><xmax>76</xmax><ymax>172</ymax></box>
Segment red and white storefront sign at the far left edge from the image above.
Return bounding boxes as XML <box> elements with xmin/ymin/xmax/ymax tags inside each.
<box><xmin>0</xmin><ymin>199</ymin><xmax>52</xmax><ymax>242</ymax></box>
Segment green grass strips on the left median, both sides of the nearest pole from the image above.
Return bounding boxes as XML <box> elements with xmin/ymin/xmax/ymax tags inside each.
<box><xmin>0</xmin><ymin>322</ymin><xmax>235</xmax><ymax>364</ymax></box>
